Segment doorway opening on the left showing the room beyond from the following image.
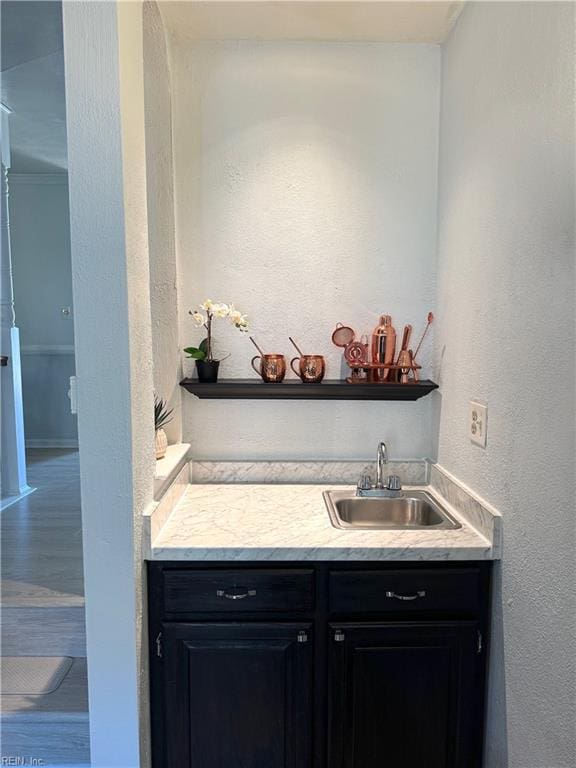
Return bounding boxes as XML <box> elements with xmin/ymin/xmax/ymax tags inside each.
<box><xmin>0</xmin><ymin>2</ymin><xmax>90</xmax><ymax>766</ymax></box>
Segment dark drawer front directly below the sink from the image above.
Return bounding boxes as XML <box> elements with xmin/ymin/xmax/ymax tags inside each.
<box><xmin>329</xmin><ymin>568</ymin><xmax>480</xmax><ymax>614</ymax></box>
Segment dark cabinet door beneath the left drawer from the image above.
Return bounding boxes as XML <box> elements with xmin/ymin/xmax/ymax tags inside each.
<box><xmin>163</xmin><ymin>623</ymin><xmax>313</xmax><ymax>768</ymax></box>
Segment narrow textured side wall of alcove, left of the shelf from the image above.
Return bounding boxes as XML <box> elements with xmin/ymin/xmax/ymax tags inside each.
<box><xmin>144</xmin><ymin>2</ymin><xmax>182</xmax><ymax>443</ymax></box>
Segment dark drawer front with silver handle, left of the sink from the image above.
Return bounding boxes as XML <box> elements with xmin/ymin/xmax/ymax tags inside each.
<box><xmin>163</xmin><ymin>570</ymin><xmax>314</xmax><ymax>613</ymax></box>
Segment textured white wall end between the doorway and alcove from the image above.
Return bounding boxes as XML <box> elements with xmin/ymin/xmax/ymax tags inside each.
<box><xmin>63</xmin><ymin>0</ymin><xmax>154</xmax><ymax>768</ymax></box>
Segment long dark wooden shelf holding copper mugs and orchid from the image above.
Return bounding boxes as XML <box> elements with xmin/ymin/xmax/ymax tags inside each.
<box><xmin>180</xmin><ymin>379</ymin><xmax>438</xmax><ymax>401</ymax></box>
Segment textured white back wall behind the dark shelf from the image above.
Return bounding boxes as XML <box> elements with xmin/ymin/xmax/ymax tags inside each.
<box><xmin>173</xmin><ymin>42</ymin><xmax>440</xmax><ymax>458</ymax></box>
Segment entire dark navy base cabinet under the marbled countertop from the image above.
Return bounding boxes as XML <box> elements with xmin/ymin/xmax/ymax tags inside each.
<box><xmin>148</xmin><ymin>562</ymin><xmax>491</xmax><ymax>768</ymax></box>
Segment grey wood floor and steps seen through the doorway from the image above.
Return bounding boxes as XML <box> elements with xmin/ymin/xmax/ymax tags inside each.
<box><xmin>0</xmin><ymin>449</ymin><xmax>90</xmax><ymax>766</ymax></box>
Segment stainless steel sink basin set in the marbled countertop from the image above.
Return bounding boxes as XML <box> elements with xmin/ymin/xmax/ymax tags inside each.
<box><xmin>323</xmin><ymin>490</ymin><xmax>462</xmax><ymax>531</ymax></box>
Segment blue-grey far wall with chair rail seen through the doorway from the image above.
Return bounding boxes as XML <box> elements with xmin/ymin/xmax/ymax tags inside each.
<box><xmin>9</xmin><ymin>173</ymin><xmax>78</xmax><ymax>446</ymax></box>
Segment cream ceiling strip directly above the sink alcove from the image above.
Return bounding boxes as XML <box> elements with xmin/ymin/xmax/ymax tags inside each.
<box><xmin>159</xmin><ymin>0</ymin><xmax>464</xmax><ymax>43</ymax></box>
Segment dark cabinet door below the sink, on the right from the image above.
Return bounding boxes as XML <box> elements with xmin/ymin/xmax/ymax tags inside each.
<box><xmin>328</xmin><ymin>622</ymin><xmax>482</xmax><ymax>768</ymax></box>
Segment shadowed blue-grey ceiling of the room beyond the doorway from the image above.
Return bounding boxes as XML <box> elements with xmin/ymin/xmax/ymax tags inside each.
<box><xmin>0</xmin><ymin>0</ymin><xmax>67</xmax><ymax>173</ymax></box>
